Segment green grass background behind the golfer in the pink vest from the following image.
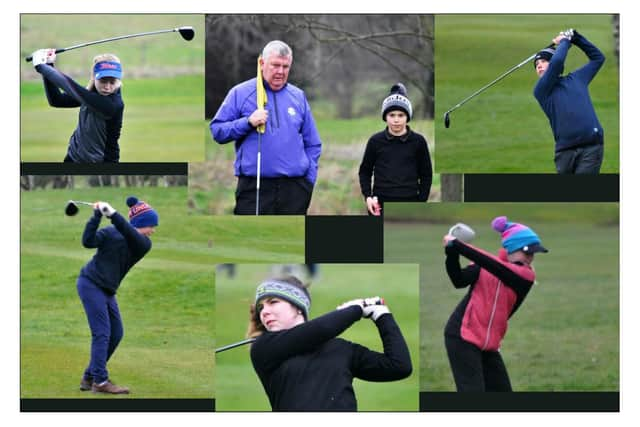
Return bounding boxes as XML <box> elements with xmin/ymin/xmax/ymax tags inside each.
<box><xmin>384</xmin><ymin>203</ymin><xmax>620</xmax><ymax>391</ymax></box>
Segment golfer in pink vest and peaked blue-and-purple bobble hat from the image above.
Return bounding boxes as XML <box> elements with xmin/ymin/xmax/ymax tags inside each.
<box><xmin>443</xmin><ymin>216</ymin><xmax>548</xmax><ymax>392</ymax></box>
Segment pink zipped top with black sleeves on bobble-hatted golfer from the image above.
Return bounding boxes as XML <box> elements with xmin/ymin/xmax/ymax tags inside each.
<box><xmin>445</xmin><ymin>240</ymin><xmax>535</xmax><ymax>351</ymax></box>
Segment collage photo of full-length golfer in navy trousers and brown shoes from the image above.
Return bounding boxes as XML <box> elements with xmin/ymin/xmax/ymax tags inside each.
<box><xmin>20</xmin><ymin>175</ymin><xmax>215</xmax><ymax>411</ymax></box>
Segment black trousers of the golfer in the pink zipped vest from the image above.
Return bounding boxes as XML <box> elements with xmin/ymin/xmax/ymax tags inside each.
<box><xmin>444</xmin><ymin>335</ymin><xmax>512</xmax><ymax>391</ymax></box>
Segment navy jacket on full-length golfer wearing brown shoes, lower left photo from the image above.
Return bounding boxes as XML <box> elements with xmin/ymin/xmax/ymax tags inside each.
<box><xmin>80</xmin><ymin>209</ymin><xmax>151</xmax><ymax>295</ymax></box>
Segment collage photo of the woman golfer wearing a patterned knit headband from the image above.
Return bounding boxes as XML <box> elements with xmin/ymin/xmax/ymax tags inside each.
<box><xmin>216</xmin><ymin>264</ymin><xmax>419</xmax><ymax>412</ymax></box>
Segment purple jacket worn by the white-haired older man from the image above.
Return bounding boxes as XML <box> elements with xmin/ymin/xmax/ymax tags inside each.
<box><xmin>209</xmin><ymin>78</ymin><xmax>322</xmax><ymax>185</ymax></box>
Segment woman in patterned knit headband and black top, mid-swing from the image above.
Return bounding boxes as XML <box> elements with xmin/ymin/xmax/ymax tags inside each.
<box><xmin>248</xmin><ymin>276</ymin><xmax>412</xmax><ymax>411</ymax></box>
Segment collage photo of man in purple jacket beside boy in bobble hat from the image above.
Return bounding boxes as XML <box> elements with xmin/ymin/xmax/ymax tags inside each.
<box><xmin>200</xmin><ymin>14</ymin><xmax>440</xmax><ymax>215</ymax></box>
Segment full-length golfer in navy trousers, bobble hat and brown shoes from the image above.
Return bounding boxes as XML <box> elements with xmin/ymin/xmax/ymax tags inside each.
<box><xmin>77</xmin><ymin>197</ymin><xmax>158</xmax><ymax>394</ymax></box>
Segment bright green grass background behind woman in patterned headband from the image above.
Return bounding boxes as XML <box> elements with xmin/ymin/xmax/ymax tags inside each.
<box><xmin>216</xmin><ymin>264</ymin><xmax>419</xmax><ymax>411</ymax></box>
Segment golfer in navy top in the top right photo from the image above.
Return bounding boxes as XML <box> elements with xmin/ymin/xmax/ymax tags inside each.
<box><xmin>533</xmin><ymin>30</ymin><xmax>604</xmax><ymax>174</ymax></box>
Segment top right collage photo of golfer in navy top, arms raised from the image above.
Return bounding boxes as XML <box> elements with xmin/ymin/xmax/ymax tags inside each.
<box><xmin>435</xmin><ymin>14</ymin><xmax>620</xmax><ymax>174</ymax></box>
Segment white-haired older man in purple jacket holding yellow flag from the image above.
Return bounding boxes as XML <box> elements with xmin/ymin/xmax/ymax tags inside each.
<box><xmin>210</xmin><ymin>40</ymin><xmax>322</xmax><ymax>215</ymax></box>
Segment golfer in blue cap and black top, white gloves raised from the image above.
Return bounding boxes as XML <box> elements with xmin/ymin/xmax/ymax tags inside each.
<box><xmin>32</xmin><ymin>49</ymin><xmax>124</xmax><ymax>163</ymax></box>
